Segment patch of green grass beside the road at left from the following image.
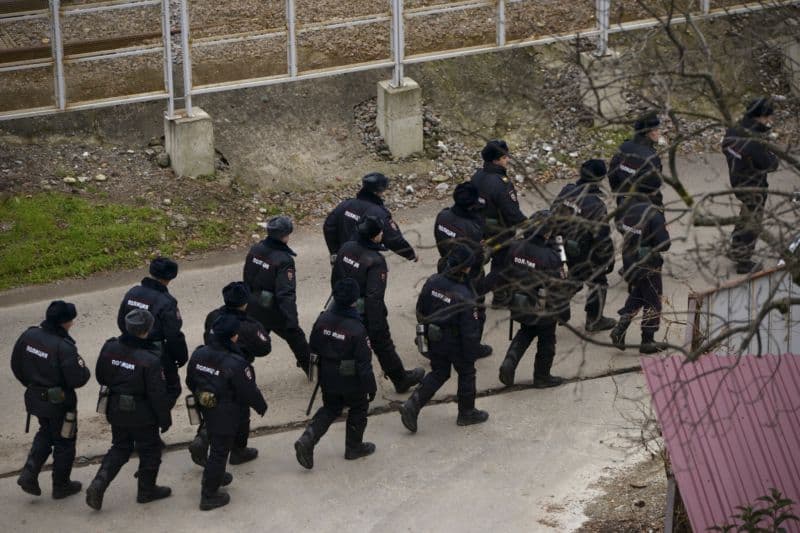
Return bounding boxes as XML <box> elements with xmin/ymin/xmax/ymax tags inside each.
<box><xmin>0</xmin><ymin>193</ymin><xmax>230</xmax><ymax>290</ymax></box>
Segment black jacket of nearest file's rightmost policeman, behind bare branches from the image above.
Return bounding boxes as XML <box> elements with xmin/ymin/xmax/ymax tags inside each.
<box><xmin>618</xmin><ymin>195</ymin><xmax>670</xmax><ymax>281</ymax></box>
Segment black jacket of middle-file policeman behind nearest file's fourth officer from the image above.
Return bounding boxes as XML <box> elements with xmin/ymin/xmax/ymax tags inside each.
<box><xmin>331</xmin><ymin>237</ymin><xmax>389</xmax><ymax>331</ymax></box>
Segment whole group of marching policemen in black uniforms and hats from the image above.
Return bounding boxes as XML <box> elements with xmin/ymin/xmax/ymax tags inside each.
<box><xmin>11</xmin><ymin>98</ymin><xmax>777</xmax><ymax>510</ymax></box>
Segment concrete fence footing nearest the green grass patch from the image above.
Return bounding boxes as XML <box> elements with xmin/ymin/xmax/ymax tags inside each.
<box><xmin>164</xmin><ymin>107</ymin><xmax>214</xmax><ymax>178</ymax></box>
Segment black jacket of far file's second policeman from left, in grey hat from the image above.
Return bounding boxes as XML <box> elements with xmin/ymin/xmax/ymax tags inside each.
<box><xmin>243</xmin><ymin>237</ymin><xmax>299</xmax><ymax>329</ymax></box>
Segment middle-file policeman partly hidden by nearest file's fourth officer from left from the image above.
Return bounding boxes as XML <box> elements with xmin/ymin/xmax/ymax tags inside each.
<box><xmin>331</xmin><ymin>215</ymin><xmax>425</xmax><ymax>393</ymax></box>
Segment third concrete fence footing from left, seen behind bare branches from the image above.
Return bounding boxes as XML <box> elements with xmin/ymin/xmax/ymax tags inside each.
<box><xmin>581</xmin><ymin>50</ymin><xmax>628</xmax><ymax>122</ymax></box>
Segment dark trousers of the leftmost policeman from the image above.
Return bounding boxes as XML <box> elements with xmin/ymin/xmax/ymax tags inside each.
<box><xmin>24</xmin><ymin>415</ymin><xmax>76</xmax><ymax>486</ymax></box>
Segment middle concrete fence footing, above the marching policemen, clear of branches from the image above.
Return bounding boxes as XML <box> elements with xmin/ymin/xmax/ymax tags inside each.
<box><xmin>377</xmin><ymin>78</ymin><xmax>422</xmax><ymax>157</ymax></box>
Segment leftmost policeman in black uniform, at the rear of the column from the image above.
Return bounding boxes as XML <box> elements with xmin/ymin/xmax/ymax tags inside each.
<box><xmin>11</xmin><ymin>300</ymin><xmax>91</xmax><ymax>500</ymax></box>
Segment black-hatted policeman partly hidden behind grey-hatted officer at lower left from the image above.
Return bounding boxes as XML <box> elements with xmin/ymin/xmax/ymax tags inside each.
<box><xmin>117</xmin><ymin>257</ymin><xmax>189</xmax><ymax>406</ymax></box>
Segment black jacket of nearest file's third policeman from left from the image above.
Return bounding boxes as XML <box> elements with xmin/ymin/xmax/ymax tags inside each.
<box><xmin>186</xmin><ymin>338</ymin><xmax>267</xmax><ymax>435</ymax></box>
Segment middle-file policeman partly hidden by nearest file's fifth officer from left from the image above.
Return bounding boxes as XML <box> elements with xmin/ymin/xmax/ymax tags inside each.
<box><xmin>433</xmin><ymin>182</ymin><xmax>492</xmax><ymax>357</ymax></box>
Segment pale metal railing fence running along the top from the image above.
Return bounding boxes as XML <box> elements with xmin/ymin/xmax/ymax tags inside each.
<box><xmin>0</xmin><ymin>0</ymin><xmax>800</xmax><ymax>120</ymax></box>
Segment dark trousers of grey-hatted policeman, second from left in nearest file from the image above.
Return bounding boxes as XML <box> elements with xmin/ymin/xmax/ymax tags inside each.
<box><xmin>97</xmin><ymin>425</ymin><xmax>161</xmax><ymax>485</ymax></box>
